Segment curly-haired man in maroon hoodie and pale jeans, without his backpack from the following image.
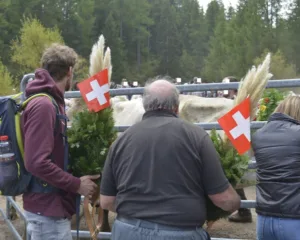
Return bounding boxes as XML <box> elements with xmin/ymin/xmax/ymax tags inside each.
<box><xmin>22</xmin><ymin>44</ymin><xmax>99</xmax><ymax>240</ymax></box>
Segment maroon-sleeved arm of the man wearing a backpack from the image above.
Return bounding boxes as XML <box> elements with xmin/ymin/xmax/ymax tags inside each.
<box><xmin>24</xmin><ymin>97</ymin><xmax>81</xmax><ymax>193</ymax></box>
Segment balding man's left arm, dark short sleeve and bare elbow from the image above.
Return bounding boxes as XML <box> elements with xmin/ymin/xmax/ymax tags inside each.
<box><xmin>100</xmin><ymin>144</ymin><xmax>117</xmax><ymax>212</ymax></box>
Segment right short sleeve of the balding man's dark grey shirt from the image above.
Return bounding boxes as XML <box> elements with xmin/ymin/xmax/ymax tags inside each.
<box><xmin>200</xmin><ymin>135</ymin><xmax>229</xmax><ymax>195</ymax></box>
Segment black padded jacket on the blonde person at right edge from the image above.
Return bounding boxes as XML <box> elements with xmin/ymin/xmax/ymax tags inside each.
<box><xmin>252</xmin><ymin>113</ymin><xmax>300</xmax><ymax>218</ymax></box>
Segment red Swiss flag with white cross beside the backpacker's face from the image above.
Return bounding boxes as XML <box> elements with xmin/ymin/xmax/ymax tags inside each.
<box><xmin>78</xmin><ymin>69</ymin><xmax>110</xmax><ymax>112</ymax></box>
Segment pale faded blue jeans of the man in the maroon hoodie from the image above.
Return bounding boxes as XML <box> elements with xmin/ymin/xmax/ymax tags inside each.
<box><xmin>24</xmin><ymin>211</ymin><xmax>72</xmax><ymax>240</ymax></box>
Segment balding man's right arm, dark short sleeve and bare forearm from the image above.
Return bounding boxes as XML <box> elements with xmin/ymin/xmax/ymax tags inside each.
<box><xmin>200</xmin><ymin>135</ymin><xmax>241</xmax><ymax>212</ymax></box>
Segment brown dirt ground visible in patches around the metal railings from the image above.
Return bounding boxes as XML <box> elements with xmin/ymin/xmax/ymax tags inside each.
<box><xmin>0</xmin><ymin>187</ymin><xmax>256</xmax><ymax>240</ymax></box>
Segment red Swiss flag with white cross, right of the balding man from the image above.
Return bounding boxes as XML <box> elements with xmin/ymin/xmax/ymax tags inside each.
<box><xmin>218</xmin><ymin>97</ymin><xmax>251</xmax><ymax>155</ymax></box>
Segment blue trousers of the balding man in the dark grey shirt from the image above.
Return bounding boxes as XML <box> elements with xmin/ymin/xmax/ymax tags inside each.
<box><xmin>111</xmin><ymin>219</ymin><xmax>209</xmax><ymax>240</ymax></box>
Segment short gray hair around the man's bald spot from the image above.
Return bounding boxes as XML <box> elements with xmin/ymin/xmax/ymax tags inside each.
<box><xmin>143</xmin><ymin>77</ymin><xmax>179</xmax><ymax>112</ymax></box>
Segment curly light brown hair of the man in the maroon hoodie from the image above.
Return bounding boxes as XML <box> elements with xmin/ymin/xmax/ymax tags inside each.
<box><xmin>41</xmin><ymin>43</ymin><xmax>78</xmax><ymax>82</ymax></box>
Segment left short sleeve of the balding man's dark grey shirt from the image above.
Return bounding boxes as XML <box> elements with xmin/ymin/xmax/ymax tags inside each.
<box><xmin>100</xmin><ymin>147</ymin><xmax>117</xmax><ymax>196</ymax></box>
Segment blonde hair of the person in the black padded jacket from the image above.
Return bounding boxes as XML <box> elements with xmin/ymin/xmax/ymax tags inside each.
<box><xmin>274</xmin><ymin>96</ymin><xmax>300</xmax><ymax>122</ymax></box>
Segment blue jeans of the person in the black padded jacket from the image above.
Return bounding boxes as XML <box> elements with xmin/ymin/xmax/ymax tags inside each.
<box><xmin>256</xmin><ymin>215</ymin><xmax>300</xmax><ymax>240</ymax></box>
